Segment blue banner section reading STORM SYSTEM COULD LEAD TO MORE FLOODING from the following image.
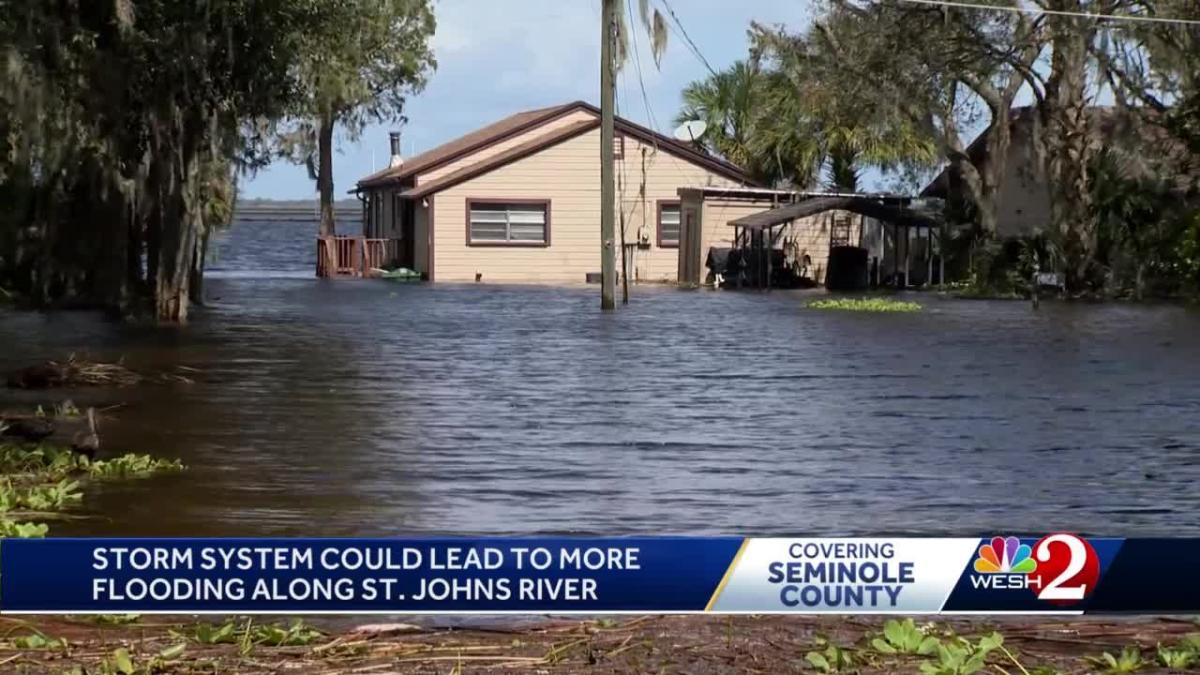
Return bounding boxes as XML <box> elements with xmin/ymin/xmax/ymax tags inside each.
<box><xmin>0</xmin><ymin>538</ymin><xmax>742</xmax><ymax>614</ymax></box>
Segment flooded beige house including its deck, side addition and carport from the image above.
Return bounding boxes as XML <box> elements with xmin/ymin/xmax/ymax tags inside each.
<box><xmin>338</xmin><ymin>101</ymin><xmax>945</xmax><ymax>285</ymax></box>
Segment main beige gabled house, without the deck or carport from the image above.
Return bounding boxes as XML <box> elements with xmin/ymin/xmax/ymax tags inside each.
<box><xmin>353</xmin><ymin>101</ymin><xmax>758</xmax><ymax>283</ymax></box>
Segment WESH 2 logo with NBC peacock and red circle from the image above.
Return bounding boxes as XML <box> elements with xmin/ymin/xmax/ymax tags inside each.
<box><xmin>971</xmin><ymin>533</ymin><xmax>1100</xmax><ymax>604</ymax></box>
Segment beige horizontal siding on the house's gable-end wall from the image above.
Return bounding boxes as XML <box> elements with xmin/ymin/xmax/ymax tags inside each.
<box><xmin>422</xmin><ymin>125</ymin><xmax>734</xmax><ymax>282</ymax></box>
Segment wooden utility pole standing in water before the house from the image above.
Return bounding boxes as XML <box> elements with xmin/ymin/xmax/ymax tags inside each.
<box><xmin>600</xmin><ymin>0</ymin><xmax>617</xmax><ymax>310</ymax></box>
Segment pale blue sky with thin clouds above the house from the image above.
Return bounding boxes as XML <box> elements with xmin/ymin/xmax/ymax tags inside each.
<box><xmin>241</xmin><ymin>0</ymin><xmax>812</xmax><ymax>199</ymax></box>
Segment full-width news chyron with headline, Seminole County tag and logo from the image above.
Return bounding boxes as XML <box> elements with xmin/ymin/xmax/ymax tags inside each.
<box><xmin>0</xmin><ymin>533</ymin><xmax>1200</xmax><ymax>614</ymax></box>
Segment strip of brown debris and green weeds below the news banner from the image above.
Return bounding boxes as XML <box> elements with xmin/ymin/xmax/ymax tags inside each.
<box><xmin>0</xmin><ymin>615</ymin><xmax>1200</xmax><ymax>675</ymax></box>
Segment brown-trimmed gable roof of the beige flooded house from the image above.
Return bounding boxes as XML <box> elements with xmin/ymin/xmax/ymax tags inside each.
<box><xmin>354</xmin><ymin>101</ymin><xmax>754</xmax><ymax>195</ymax></box>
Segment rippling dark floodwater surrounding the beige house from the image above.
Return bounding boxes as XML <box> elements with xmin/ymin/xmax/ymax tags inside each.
<box><xmin>0</xmin><ymin>223</ymin><xmax>1200</xmax><ymax>536</ymax></box>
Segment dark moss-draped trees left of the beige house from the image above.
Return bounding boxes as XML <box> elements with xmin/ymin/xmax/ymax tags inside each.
<box><xmin>0</xmin><ymin>0</ymin><xmax>432</xmax><ymax>323</ymax></box>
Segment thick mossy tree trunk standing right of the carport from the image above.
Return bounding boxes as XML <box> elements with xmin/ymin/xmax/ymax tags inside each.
<box><xmin>1042</xmin><ymin>0</ymin><xmax>1097</xmax><ymax>292</ymax></box>
